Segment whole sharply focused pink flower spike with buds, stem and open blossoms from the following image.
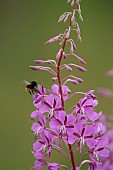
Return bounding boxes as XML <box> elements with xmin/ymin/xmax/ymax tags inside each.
<box><xmin>26</xmin><ymin>0</ymin><xmax>109</xmax><ymax>170</ymax></box>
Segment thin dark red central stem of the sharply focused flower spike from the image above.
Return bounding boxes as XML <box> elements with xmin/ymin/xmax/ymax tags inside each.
<box><xmin>57</xmin><ymin>3</ymin><xmax>76</xmax><ymax>170</ymax></box>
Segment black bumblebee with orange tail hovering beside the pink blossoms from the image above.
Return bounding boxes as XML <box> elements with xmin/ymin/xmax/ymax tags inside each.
<box><xmin>25</xmin><ymin>81</ymin><xmax>37</xmax><ymax>95</ymax></box>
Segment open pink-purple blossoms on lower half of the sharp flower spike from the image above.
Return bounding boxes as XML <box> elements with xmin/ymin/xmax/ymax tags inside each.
<box><xmin>30</xmin><ymin>84</ymin><xmax>109</xmax><ymax>170</ymax></box>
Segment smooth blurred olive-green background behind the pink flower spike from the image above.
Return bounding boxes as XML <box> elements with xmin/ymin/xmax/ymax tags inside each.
<box><xmin>0</xmin><ymin>0</ymin><xmax>113</xmax><ymax>170</ymax></box>
